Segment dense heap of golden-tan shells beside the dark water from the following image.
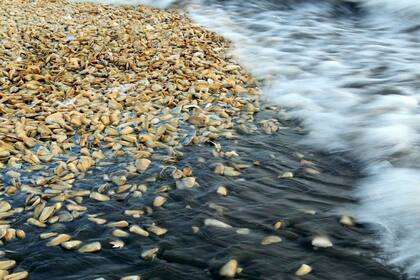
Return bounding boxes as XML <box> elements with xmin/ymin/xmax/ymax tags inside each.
<box><xmin>0</xmin><ymin>0</ymin><xmax>260</xmax><ymax>279</ymax></box>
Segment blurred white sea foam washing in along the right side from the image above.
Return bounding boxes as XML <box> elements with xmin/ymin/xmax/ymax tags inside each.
<box><xmin>190</xmin><ymin>0</ymin><xmax>420</xmax><ymax>276</ymax></box>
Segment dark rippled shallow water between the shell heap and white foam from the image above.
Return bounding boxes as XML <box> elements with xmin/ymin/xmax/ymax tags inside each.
<box><xmin>3</xmin><ymin>106</ymin><xmax>403</xmax><ymax>279</ymax></box>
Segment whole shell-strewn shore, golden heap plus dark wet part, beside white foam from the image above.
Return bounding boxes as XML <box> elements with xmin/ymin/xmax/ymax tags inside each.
<box><xmin>0</xmin><ymin>1</ymin><xmax>406</xmax><ymax>279</ymax></box>
